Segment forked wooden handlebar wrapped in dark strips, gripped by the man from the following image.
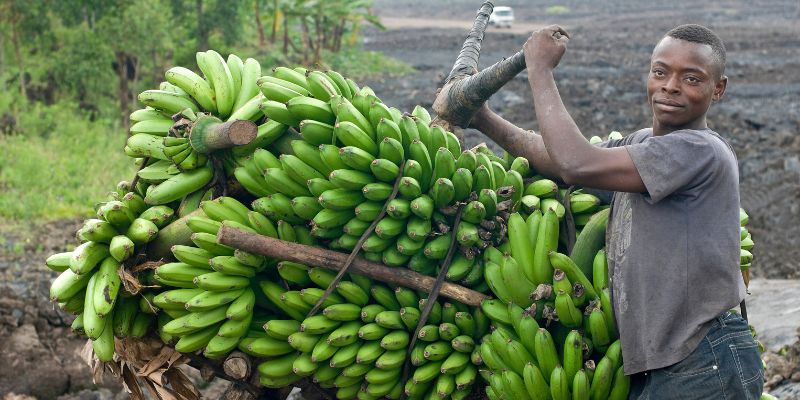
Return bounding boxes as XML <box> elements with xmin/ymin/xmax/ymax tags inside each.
<box><xmin>431</xmin><ymin>1</ymin><xmax>525</xmax><ymax>143</ymax></box>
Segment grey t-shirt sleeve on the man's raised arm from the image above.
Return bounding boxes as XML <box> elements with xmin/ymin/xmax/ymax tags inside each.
<box><xmin>625</xmin><ymin>131</ymin><xmax>717</xmax><ymax>203</ymax></box>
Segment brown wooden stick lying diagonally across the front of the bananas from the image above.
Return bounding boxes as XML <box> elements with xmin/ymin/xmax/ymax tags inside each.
<box><xmin>217</xmin><ymin>224</ymin><xmax>489</xmax><ymax>307</ymax></box>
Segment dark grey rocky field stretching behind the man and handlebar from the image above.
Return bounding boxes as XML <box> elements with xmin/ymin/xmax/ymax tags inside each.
<box><xmin>364</xmin><ymin>0</ymin><xmax>800</xmax><ymax>278</ymax></box>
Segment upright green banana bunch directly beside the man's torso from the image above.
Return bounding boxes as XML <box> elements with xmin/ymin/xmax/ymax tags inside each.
<box><xmin>468</xmin><ymin>173</ymin><xmax>630</xmax><ymax>400</ymax></box>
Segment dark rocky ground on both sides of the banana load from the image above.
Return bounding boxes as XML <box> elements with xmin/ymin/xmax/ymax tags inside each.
<box><xmin>0</xmin><ymin>0</ymin><xmax>800</xmax><ymax>400</ymax></box>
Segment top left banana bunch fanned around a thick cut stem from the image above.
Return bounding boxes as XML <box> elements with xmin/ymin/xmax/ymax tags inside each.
<box><xmin>125</xmin><ymin>50</ymin><xmax>276</xmax><ymax>209</ymax></box>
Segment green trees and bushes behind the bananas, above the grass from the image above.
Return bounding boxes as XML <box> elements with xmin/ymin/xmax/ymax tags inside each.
<box><xmin>0</xmin><ymin>0</ymin><xmax>381</xmax><ymax>126</ymax></box>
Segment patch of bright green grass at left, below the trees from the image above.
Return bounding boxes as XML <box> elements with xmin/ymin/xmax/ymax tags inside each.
<box><xmin>0</xmin><ymin>94</ymin><xmax>134</xmax><ymax>222</ymax></box>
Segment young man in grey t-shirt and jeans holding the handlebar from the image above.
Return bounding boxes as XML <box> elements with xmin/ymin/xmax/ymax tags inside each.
<box><xmin>472</xmin><ymin>25</ymin><xmax>764</xmax><ymax>400</ymax></box>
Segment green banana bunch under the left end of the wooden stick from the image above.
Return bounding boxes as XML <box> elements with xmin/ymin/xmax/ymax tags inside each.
<box><xmin>144</xmin><ymin>197</ymin><xmax>277</xmax><ymax>359</ymax></box>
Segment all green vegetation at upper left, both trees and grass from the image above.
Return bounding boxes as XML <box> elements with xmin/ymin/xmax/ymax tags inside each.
<box><xmin>0</xmin><ymin>0</ymin><xmax>411</xmax><ymax>228</ymax></box>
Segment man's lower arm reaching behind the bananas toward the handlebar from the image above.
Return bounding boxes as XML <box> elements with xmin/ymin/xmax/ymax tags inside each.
<box><xmin>470</xmin><ymin>104</ymin><xmax>563</xmax><ymax>180</ymax></box>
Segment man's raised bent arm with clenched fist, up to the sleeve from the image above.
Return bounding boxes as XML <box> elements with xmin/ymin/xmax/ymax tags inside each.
<box><xmin>523</xmin><ymin>25</ymin><xmax>646</xmax><ymax>193</ymax></box>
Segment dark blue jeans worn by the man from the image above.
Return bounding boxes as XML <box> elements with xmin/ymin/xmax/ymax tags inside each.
<box><xmin>628</xmin><ymin>312</ymin><xmax>764</xmax><ymax>400</ymax></box>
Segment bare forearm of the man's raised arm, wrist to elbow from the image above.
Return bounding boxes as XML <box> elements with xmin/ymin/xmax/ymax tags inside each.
<box><xmin>528</xmin><ymin>70</ymin><xmax>593</xmax><ymax>179</ymax></box>
